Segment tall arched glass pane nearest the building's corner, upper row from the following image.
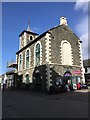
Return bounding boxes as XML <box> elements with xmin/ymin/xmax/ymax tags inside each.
<box><xmin>35</xmin><ymin>43</ymin><xmax>40</xmax><ymax>66</ymax></box>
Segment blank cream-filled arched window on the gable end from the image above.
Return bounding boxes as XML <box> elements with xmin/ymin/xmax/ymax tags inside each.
<box><xmin>61</xmin><ymin>40</ymin><xmax>72</xmax><ymax>65</ymax></box>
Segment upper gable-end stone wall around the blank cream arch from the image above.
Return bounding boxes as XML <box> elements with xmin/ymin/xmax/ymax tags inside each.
<box><xmin>51</xmin><ymin>26</ymin><xmax>80</xmax><ymax>66</ymax></box>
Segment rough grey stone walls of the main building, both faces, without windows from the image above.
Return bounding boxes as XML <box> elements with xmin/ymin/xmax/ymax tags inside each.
<box><xmin>17</xmin><ymin>26</ymin><xmax>81</xmax><ymax>91</ymax></box>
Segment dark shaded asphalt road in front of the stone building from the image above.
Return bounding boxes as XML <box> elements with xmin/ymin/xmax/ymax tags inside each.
<box><xmin>2</xmin><ymin>91</ymin><xmax>88</xmax><ymax>118</ymax></box>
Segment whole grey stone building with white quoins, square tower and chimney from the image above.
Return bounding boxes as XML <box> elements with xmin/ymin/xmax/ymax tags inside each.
<box><xmin>16</xmin><ymin>17</ymin><xmax>85</xmax><ymax>91</ymax></box>
